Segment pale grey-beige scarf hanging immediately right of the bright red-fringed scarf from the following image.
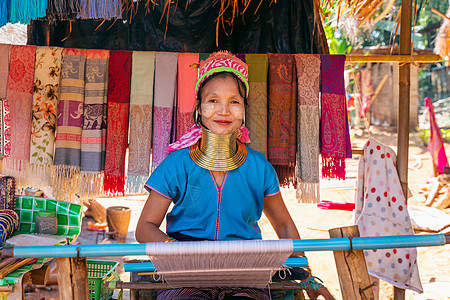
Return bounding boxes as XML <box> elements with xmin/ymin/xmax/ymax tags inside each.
<box><xmin>127</xmin><ymin>51</ymin><xmax>155</xmax><ymax>194</ymax></box>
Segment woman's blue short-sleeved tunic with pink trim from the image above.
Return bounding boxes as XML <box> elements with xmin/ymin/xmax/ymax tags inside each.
<box><xmin>145</xmin><ymin>147</ymin><xmax>280</xmax><ymax>240</ymax></box>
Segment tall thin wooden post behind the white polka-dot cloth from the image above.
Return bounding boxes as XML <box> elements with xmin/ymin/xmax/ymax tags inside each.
<box><xmin>400</xmin><ymin>0</ymin><xmax>412</xmax><ymax>300</ymax></box>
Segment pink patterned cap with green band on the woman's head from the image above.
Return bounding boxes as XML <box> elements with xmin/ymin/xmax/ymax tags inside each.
<box><xmin>195</xmin><ymin>51</ymin><xmax>248</xmax><ymax>99</ymax></box>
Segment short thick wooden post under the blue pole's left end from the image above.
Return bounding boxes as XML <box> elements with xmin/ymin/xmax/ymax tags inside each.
<box><xmin>56</xmin><ymin>257</ymin><xmax>89</xmax><ymax>300</ymax></box>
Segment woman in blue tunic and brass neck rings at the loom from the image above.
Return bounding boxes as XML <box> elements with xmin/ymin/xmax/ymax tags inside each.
<box><xmin>136</xmin><ymin>52</ymin><xmax>331</xmax><ymax>299</ymax></box>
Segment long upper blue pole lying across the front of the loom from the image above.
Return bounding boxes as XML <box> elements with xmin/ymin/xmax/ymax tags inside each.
<box><xmin>2</xmin><ymin>234</ymin><xmax>450</xmax><ymax>258</ymax></box>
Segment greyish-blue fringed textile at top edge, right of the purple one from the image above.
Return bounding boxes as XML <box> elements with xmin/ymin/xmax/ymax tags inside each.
<box><xmin>77</xmin><ymin>0</ymin><xmax>122</xmax><ymax>20</ymax></box>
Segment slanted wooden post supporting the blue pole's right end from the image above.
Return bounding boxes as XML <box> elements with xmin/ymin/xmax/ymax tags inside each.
<box><xmin>328</xmin><ymin>225</ymin><xmax>375</xmax><ymax>300</ymax></box>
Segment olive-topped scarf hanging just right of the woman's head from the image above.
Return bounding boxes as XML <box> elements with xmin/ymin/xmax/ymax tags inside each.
<box><xmin>245</xmin><ymin>54</ymin><xmax>269</xmax><ymax>157</ymax></box>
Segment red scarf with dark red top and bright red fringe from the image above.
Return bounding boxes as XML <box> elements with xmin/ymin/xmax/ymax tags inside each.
<box><xmin>103</xmin><ymin>51</ymin><xmax>133</xmax><ymax>195</ymax></box>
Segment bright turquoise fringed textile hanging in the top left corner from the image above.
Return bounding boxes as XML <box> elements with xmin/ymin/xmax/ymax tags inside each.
<box><xmin>9</xmin><ymin>0</ymin><xmax>48</xmax><ymax>24</ymax></box>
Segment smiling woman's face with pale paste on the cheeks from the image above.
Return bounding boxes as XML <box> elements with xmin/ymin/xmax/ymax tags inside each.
<box><xmin>200</xmin><ymin>75</ymin><xmax>245</xmax><ymax>135</ymax></box>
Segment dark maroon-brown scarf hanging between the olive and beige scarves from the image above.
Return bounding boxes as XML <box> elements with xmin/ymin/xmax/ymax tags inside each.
<box><xmin>268</xmin><ymin>54</ymin><xmax>297</xmax><ymax>186</ymax></box>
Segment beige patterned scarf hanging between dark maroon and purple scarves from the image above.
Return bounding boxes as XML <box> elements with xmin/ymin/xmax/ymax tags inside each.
<box><xmin>295</xmin><ymin>54</ymin><xmax>320</xmax><ymax>203</ymax></box>
